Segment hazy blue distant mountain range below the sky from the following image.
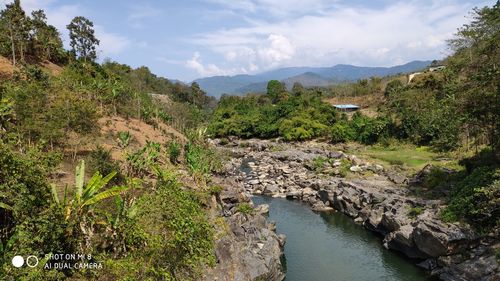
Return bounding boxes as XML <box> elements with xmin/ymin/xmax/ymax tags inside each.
<box><xmin>193</xmin><ymin>61</ymin><xmax>431</xmax><ymax>97</ymax></box>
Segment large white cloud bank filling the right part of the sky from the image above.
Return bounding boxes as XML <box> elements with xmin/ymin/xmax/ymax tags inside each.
<box><xmin>190</xmin><ymin>0</ymin><xmax>480</xmax><ymax>74</ymax></box>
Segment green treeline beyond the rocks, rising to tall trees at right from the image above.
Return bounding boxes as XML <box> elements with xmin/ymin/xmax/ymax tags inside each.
<box><xmin>210</xmin><ymin>3</ymin><xmax>500</xmax><ymax>152</ymax></box>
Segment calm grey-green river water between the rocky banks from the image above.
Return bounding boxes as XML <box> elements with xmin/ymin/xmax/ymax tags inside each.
<box><xmin>253</xmin><ymin>197</ymin><xmax>430</xmax><ymax>281</ymax></box>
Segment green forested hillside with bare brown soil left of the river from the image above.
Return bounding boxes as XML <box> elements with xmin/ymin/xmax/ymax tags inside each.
<box><xmin>0</xmin><ymin>0</ymin><xmax>224</xmax><ymax>280</ymax></box>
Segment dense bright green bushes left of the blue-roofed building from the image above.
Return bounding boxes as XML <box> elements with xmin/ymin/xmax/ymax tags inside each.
<box><xmin>209</xmin><ymin>88</ymin><xmax>337</xmax><ymax>140</ymax></box>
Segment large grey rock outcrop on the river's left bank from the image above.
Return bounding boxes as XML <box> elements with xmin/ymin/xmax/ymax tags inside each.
<box><xmin>203</xmin><ymin>179</ymin><xmax>285</xmax><ymax>281</ymax></box>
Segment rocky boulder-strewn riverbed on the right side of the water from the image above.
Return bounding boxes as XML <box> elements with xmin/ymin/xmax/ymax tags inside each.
<box><xmin>214</xmin><ymin>140</ymin><xmax>500</xmax><ymax>280</ymax></box>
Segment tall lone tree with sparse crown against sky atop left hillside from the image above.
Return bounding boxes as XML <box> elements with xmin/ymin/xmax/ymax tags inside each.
<box><xmin>66</xmin><ymin>16</ymin><xmax>99</xmax><ymax>61</ymax></box>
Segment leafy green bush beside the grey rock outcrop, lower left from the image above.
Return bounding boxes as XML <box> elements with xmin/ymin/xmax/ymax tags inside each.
<box><xmin>137</xmin><ymin>173</ymin><xmax>215</xmax><ymax>280</ymax></box>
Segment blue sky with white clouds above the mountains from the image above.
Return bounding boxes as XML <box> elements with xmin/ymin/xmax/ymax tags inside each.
<box><xmin>0</xmin><ymin>0</ymin><xmax>495</xmax><ymax>82</ymax></box>
